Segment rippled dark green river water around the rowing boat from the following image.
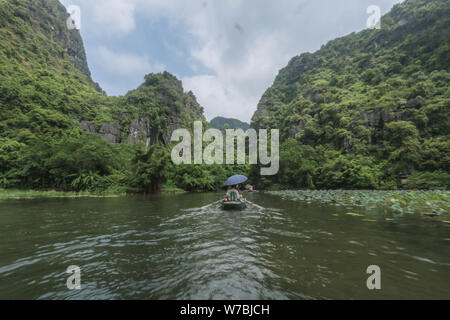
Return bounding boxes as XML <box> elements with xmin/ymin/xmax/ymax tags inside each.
<box><xmin>0</xmin><ymin>193</ymin><xmax>450</xmax><ymax>299</ymax></box>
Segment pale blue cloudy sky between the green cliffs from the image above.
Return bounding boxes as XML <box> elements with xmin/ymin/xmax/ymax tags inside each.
<box><xmin>60</xmin><ymin>0</ymin><xmax>401</xmax><ymax>122</ymax></box>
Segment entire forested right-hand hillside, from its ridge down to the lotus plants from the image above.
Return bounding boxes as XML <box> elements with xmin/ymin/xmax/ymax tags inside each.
<box><xmin>252</xmin><ymin>0</ymin><xmax>450</xmax><ymax>189</ymax></box>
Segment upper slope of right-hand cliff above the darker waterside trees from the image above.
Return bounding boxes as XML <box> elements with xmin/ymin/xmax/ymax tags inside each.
<box><xmin>252</xmin><ymin>0</ymin><xmax>450</xmax><ymax>151</ymax></box>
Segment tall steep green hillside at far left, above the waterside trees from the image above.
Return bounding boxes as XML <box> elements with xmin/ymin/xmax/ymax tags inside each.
<box><xmin>0</xmin><ymin>0</ymin><xmax>106</xmax><ymax>143</ymax></box>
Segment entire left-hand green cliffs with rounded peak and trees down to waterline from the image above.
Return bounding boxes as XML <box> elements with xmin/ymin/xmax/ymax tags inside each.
<box><xmin>0</xmin><ymin>0</ymin><xmax>244</xmax><ymax>196</ymax></box>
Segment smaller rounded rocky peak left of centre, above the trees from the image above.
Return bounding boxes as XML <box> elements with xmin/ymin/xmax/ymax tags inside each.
<box><xmin>80</xmin><ymin>72</ymin><xmax>204</xmax><ymax>147</ymax></box>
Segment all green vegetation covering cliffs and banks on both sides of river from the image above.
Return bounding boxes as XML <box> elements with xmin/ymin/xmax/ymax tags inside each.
<box><xmin>0</xmin><ymin>0</ymin><xmax>450</xmax><ymax>194</ymax></box>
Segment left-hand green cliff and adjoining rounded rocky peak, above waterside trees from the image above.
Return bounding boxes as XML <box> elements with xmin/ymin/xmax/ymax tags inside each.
<box><xmin>0</xmin><ymin>0</ymin><xmax>203</xmax><ymax>146</ymax></box>
